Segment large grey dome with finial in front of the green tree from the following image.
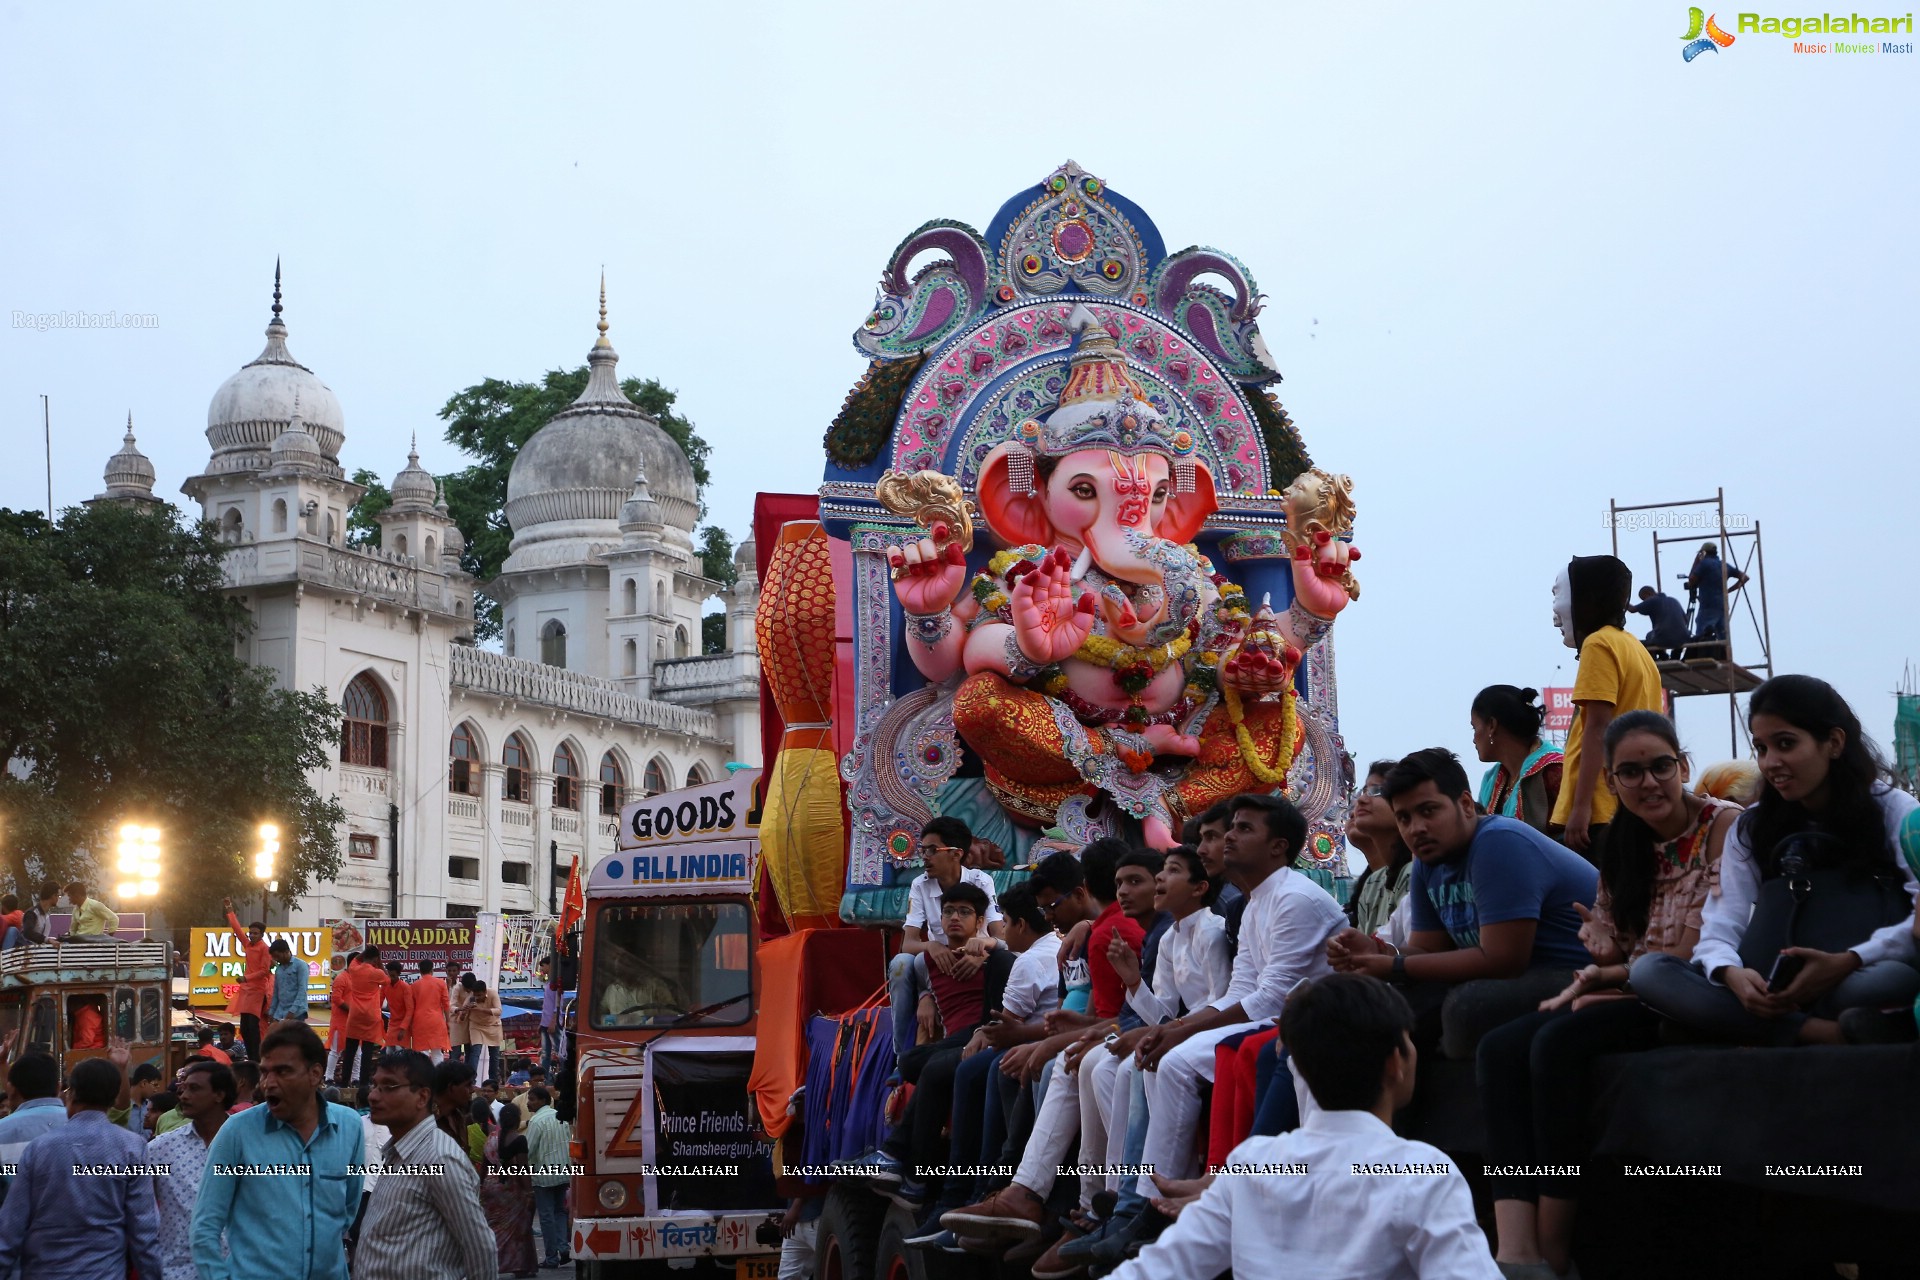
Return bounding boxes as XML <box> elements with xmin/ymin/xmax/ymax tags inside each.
<box><xmin>507</xmin><ymin>276</ymin><xmax>699</xmax><ymax>560</ymax></box>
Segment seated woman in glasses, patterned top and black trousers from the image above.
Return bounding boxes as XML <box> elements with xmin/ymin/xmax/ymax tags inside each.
<box><xmin>1478</xmin><ymin>710</ymin><xmax>1740</xmax><ymax>1280</ymax></box>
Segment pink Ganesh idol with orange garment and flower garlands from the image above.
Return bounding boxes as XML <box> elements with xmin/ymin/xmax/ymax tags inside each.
<box><xmin>883</xmin><ymin>305</ymin><xmax>1359</xmax><ymax>848</ymax></box>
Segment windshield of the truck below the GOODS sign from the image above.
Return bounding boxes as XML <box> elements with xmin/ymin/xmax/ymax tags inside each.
<box><xmin>588</xmin><ymin>902</ymin><xmax>753</xmax><ymax>1027</ymax></box>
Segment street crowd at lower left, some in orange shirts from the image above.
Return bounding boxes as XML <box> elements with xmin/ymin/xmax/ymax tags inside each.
<box><xmin>0</xmin><ymin>924</ymin><xmax>572</xmax><ymax>1280</ymax></box>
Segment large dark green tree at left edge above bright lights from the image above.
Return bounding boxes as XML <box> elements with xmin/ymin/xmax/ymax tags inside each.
<box><xmin>0</xmin><ymin>505</ymin><xmax>346</xmax><ymax>919</ymax></box>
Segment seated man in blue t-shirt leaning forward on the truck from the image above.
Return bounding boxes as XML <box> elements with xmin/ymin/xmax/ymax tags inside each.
<box><xmin>1327</xmin><ymin>747</ymin><xmax>1599</xmax><ymax>1059</ymax></box>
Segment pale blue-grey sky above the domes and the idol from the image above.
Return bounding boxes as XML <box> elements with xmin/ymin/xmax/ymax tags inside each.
<box><xmin>0</xmin><ymin>0</ymin><xmax>1920</xmax><ymax>773</ymax></box>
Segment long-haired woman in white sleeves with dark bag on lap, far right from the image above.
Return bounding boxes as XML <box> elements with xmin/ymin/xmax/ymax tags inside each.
<box><xmin>1632</xmin><ymin>676</ymin><xmax>1920</xmax><ymax>1046</ymax></box>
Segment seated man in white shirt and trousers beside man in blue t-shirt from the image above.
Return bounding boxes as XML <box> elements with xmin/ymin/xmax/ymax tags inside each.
<box><xmin>1135</xmin><ymin>794</ymin><xmax>1346</xmax><ymax>1228</ymax></box>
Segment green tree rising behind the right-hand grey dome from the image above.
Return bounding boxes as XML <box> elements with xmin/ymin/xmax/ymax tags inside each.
<box><xmin>440</xmin><ymin>365</ymin><xmax>726</xmax><ymax>639</ymax></box>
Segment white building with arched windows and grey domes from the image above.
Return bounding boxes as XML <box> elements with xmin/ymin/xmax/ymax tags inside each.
<box><xmin>110</xmin><ymin>267</ymin><xmax>760</xmax><ymax>923</ymax></box>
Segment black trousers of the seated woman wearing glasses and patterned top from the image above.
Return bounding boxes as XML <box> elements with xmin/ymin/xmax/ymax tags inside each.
<box><xmin>1475</xmin><ymin>1000</ymin><xmax>1661</xmax><ymax>1201</ymax></box>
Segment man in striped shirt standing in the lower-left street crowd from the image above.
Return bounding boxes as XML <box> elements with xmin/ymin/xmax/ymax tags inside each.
<box><xmin>353</xmin><ymin>1050</ymin><xmax>499</xmax><ymax>1280</ymax></box>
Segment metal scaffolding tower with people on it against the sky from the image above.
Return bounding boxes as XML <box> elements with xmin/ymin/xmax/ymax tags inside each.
<box><xmin>1607</xmin><ymin>489</ymin><xmax>1774</xmax><ymax>756</ymax></box>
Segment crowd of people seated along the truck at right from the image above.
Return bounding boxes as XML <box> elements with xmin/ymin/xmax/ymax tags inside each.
<box><xmin>783</xmin><ymin>557</ymin><xmax>1920</xmax><ymax>1280</ymax></box>
